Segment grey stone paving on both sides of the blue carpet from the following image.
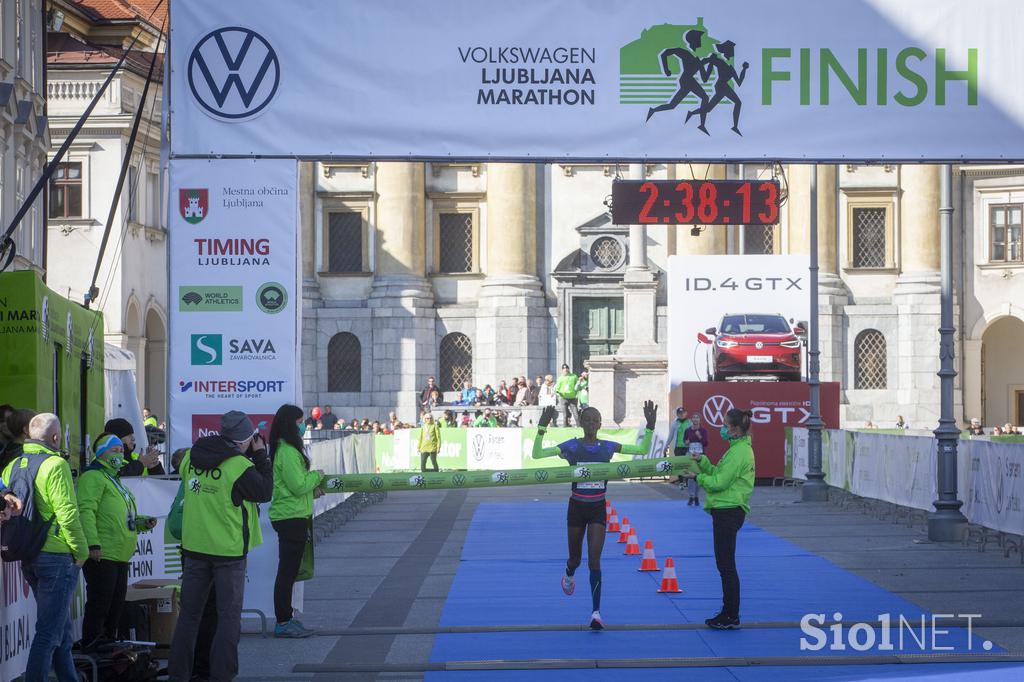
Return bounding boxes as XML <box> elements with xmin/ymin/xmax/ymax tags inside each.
<box><xmin>232</xmin><ymin>482</ymin><xmax>1024</xmax><ymax>682</ymax></box>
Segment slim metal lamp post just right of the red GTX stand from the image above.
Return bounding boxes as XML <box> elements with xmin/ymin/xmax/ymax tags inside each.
<box><xmin>801</xmin><ymin>164</ymin><xmax>828</xmax><ymax>502</ymax></box>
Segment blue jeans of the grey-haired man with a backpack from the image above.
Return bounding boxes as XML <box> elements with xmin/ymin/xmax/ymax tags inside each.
<box><xmin>22</xmin><ymin>552</ymin><xmax>80</xmax><ymax>682</ymax></box>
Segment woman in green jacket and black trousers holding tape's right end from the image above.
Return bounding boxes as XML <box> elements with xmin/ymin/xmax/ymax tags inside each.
<box><xmin>686</xmin><ymin>409</ymin><xmax>755</xmax><ymax>630</ymax></box>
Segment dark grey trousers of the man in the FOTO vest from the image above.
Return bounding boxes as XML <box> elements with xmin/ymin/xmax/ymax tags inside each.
<box><xmin>168</xmin><ymin>554</ymin><xmax>246</xmax><ymax>682</ymax></box>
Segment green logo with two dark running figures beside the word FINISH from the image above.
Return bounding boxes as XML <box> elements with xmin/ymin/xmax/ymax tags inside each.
<box><xmin>618</xmin><ymin>17</ymin><xmax>750</xmax><ymax>135</ymax></box>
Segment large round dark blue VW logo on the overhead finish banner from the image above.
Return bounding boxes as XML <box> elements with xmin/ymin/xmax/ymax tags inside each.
<box><xmin>188</xmin><ymin>26</ymin><xmax>281</xmax><ymax>121</ymax></box>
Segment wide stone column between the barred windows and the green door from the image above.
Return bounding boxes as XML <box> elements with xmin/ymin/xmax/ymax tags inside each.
<box><xmin>473</xmin><ymin>163</ymin><xmax>550</xmax><ymax>383</ymax></box>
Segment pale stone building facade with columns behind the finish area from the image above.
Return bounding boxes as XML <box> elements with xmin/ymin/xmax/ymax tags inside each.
<box><xmin>300</xmin><ymin>162</ymin><xmax>1024</xmax><ymax>428</ymax></box>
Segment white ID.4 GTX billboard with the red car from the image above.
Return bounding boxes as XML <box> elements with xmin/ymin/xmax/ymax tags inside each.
<box><xmin>668</xmin><ymin>254</ymin><xmax>811</xmax><ymax>391</ymax></box>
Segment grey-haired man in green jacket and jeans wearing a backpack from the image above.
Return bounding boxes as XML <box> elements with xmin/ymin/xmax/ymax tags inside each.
<box><xmin>2</xmin><ymin>413</ymin><xmax>89</xmax><ymax>682</ymax></box>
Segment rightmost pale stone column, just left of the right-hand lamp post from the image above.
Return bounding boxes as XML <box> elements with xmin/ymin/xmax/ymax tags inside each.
<box><xmin>893</xmin><ymin>165</ymin><xmax>941</xmax><ymax>428</ymax></box>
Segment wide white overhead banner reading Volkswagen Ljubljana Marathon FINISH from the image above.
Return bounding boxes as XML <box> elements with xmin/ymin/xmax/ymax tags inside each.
<box><xmin>170</xmin><ymin>0</ymin><xmax>1024</xmax><ymax>161</ymax></box>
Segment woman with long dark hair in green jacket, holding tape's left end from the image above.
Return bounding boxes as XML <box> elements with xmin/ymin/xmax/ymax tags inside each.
<box><xmin>270</xmin><ymin>404</ymin><xmax>324</xmax><ymax>637</ymax></box>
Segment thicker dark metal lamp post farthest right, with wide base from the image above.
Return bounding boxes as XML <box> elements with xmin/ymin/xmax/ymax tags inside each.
<box><xmin>928</xmin><ymin>164</ymin><xmax>967</xmax><ymax>543</ymax></box>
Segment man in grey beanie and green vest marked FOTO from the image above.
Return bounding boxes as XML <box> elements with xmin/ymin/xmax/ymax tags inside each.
<box><xmin>168</xmin><ymin>411</ymin><xmax>273</xmax><ymax>682</ymax></box>
